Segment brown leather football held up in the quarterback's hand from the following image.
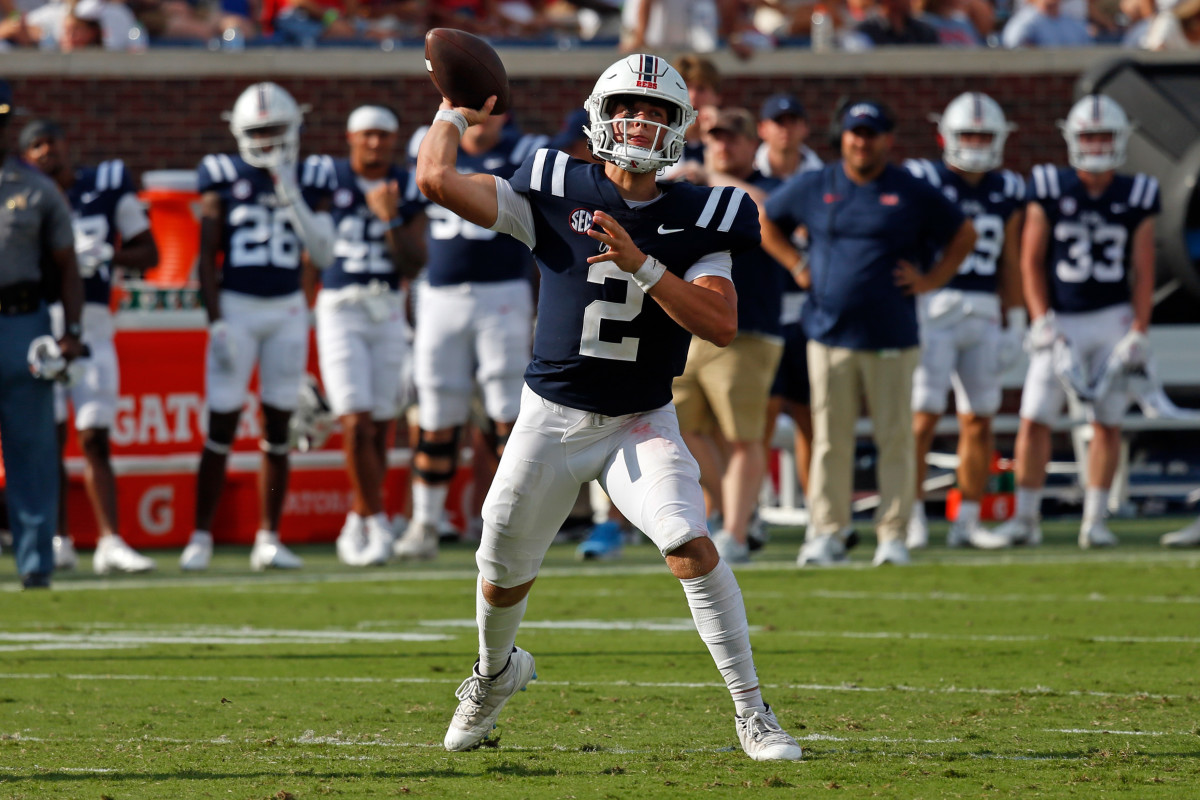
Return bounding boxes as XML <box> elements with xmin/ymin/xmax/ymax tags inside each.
<box><xmin>425</xmin><ymin>28</ymin><xmax>509</xmax><ymax>114</ymax></box>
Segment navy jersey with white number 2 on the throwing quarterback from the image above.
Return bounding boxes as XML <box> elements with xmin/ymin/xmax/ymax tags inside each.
<box><xmin>511</xmin><ymin>150</ymin><xmax>760</xmax><ymax>416</ymax></box>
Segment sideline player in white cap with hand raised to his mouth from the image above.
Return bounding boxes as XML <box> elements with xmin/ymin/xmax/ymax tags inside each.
<box><xmin>301</xmin><ymin>106</ymin><xmax>425</xmax><ymax>566</ymax></box>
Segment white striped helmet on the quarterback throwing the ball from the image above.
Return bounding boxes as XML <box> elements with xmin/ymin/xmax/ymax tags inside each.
<box><xmin>583</xmin><ymin>54</ymin><xmax>696</xmax><ymax>173</ymax></box>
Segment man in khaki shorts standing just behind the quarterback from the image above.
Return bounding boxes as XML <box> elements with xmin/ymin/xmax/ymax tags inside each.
<box><xmin>672</xmin><ymin>108</ymin><xmax>786</xmax><ymax>564</ymax></box>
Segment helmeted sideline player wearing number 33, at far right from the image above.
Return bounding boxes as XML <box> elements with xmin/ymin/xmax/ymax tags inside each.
<box><xmin>996</xmin><ymin>95</ymin><xmax>1159</xmax><ymax>548</ymax></box>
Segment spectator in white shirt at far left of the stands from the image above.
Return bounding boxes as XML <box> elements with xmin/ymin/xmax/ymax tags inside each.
<box><xmin>25</xmin><ymin>0</ymin><xmax>145</xmax><ymax>53</ymax></box>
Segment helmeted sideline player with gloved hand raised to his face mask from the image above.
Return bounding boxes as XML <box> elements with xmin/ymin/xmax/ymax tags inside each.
<box><xmin>180</xmin><ymin>83</ymin><xmax>334</xmax><ymax>571</ymax></box>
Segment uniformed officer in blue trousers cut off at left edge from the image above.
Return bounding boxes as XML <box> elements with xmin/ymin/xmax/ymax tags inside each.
<box><xmin>0</xmin><ymin>80</ymin><xmax>83</xmax><ymax>589</ymax></box>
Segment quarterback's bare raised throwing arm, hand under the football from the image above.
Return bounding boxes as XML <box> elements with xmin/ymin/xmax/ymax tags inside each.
<box><xmin>416</xmin><ymin>96</ymin><xmax>499</xmax><ymax>228</ymax></box>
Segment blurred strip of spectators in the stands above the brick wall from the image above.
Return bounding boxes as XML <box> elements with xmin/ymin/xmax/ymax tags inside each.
<box><xmin>0</xmin><ymin>0</ymin><xmax>1200</xmax><ymax>51</ymax></box>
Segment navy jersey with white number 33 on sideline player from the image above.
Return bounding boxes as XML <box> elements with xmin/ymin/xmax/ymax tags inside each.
<box><xmin>1026</xmin><ymin>164</ymin><xmax>1160</xmax><ymax>312</ymax></box>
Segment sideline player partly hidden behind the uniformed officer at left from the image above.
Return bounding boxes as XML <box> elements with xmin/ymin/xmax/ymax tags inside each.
<box><xmin>18</xmin><ymin>119</ymin><xmax>158</xmax><ymax>575</ymax></box>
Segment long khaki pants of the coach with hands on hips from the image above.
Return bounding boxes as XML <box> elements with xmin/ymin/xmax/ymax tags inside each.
<box><xmin>809</xmin><ymin>341</ymin><xmax>920</xmax><ymax>542</ymax></box>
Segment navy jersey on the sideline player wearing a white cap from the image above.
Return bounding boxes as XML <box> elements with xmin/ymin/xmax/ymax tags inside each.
<box><xmin>300</xmin><ymin>156</ymin><xmax>421</xmax><ymax>289</ymax></box>
